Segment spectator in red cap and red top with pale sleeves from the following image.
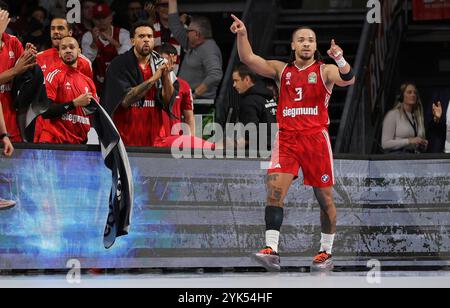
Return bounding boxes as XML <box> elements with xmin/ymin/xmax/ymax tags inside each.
<box><xmin>82</xmin><ymin>4</ymin><xmax>132</xmax><ymax>94</ymax></box>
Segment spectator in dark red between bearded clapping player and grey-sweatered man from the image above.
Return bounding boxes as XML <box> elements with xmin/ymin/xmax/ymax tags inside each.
<box><xmin>145</xmin><ymin>0</ymin><xmax>185</xmax><ymax>75</ymax></box>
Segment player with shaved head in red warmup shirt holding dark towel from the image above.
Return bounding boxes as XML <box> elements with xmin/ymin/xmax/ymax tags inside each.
<box><xmin>39</xmin><ymin>37</ymin><xmax>98</xmax><ymax>144</ymax></box>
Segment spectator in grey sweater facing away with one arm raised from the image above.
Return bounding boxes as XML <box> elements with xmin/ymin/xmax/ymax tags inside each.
<box><xmin>169</xmin><ymin>0</ymin><xmax>223</xmax><ymax>99</ymax></box>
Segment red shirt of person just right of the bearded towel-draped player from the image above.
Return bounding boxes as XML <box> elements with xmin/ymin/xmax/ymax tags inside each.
<box><xmin>163</xmin><ymin>78</ymin><xmax>194</xmax><ymax>136</ymax></box>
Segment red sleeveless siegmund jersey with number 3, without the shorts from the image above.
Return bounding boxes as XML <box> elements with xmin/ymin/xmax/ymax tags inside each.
<box><xmin>277</xmin><ymin>62</ymin><xmax>331</xmax><ymax>134</ymax></box>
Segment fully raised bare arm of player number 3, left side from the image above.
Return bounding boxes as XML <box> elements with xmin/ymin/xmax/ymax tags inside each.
<box><xmin>230</xmin><ymin>15</ymin><xmax>286</xmax><ymax>80</ymax></box>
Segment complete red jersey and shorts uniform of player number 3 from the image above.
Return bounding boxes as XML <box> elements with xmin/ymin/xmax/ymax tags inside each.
<box><xmin>269</xmin><ymin>62</ymin><xmax>334</xmax><ymax>188</ymax></box>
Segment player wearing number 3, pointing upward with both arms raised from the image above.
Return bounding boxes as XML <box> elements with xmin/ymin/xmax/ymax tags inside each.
<box><xmin>231</xmin><ymin>15</ymin><xmax>355</xmax><ymax>271</ymax></box>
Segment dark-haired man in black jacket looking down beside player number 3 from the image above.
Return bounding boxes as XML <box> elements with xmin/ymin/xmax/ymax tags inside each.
<box><xmin>233</xmin><ymin>65</ymin><xmax>277</xmax><ymax>151</ymax></box>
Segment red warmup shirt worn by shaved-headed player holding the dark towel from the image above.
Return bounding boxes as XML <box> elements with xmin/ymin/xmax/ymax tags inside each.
<box><xmin>39</xmin><ymin>64</ymin><xmax>98</xmax><ymax>144</ymax></box>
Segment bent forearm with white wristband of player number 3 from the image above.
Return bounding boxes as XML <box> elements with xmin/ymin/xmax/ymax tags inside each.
<box><xmin>324</xmin><ymin>40</ymin><xmax>355</xmax><ymax>87</ymax></box>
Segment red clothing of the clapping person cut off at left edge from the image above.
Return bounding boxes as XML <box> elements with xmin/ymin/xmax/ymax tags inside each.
<box><xmin>0</xmin><ymin>33</ymin><xmax>23</xmax><ymax>142</ymax></box>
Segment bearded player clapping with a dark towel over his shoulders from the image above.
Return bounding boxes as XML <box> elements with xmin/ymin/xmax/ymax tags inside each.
<box><xmin>111</xmin><ymin>22</ymin><xmax>176</xmax><ymax>147</ymax></box>
